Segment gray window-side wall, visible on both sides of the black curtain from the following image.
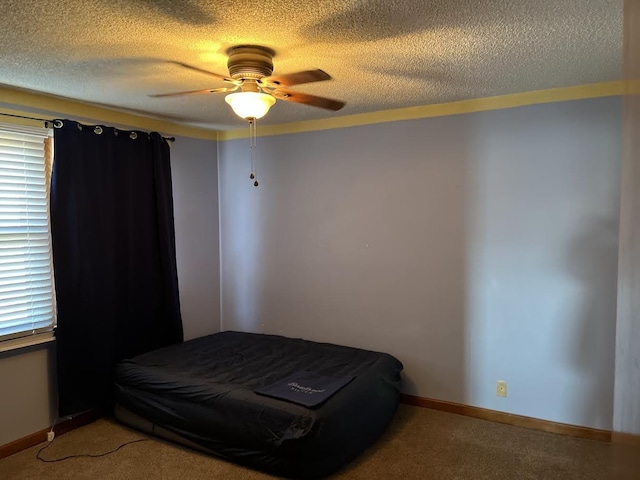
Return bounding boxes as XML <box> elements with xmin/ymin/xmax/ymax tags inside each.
<box><xmin>0</xmin><ymin>133</ymin><xmax>220</xmax><ymax>445</ymax></box>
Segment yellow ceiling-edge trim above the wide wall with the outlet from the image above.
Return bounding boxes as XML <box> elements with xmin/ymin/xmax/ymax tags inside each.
<box><xmin>218</xmin><ymin>80</ymin><xmax>640</xmax><ymax>141</ymax></box>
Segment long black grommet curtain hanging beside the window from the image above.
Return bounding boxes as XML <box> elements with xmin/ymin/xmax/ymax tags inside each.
<box><xmin>51</xmin><ymin>120</ymin><xmax>183</xmax><ymax>416</ymax></box>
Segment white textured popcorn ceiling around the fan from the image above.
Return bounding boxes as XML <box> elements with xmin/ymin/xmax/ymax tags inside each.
<box><xmin>0</xmin><ymin>0</ymin><xmax>623</xmax><ymax>129</ymax></box>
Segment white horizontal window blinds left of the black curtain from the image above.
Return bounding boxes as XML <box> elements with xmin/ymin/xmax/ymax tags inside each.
<box><xmin>0</xmin><ymin>124</ymin><xmax>55</xmax><ymax>341</ymax></box>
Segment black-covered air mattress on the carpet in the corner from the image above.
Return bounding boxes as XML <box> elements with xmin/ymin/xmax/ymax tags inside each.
<box><xmin>115</xmin><ymin>332</ymin><xmax>402</xmax><ymax>478</ymax></box>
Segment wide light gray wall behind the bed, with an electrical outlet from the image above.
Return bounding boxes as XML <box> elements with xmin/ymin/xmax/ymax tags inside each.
<box><xmin>218</xmin><ymin>98</ymin><xmax>621</xmax><ymax>428</ymax></box>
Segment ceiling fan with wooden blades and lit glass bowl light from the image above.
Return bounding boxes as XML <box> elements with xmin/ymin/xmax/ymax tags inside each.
<box><xmin>149</xmin><ymin>45</ymin><xmax>345</xmax><ymax>121</ymax></box>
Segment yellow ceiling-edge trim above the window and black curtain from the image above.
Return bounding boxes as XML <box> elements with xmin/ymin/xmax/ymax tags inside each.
<box><xmin>0</xmin><ymin>86</ymin><xmax>218</xmax><ymax>140</ymax></box>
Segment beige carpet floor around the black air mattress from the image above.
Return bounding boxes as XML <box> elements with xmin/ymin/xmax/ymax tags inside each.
<box><xmin>0</xmin><ymin>406</ymin><xmax>640</xmax><ymax>480</ymax></box>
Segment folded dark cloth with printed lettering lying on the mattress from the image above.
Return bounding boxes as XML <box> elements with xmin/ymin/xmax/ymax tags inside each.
<box><xmin>255</xmin><ymin>371</ymin><xmax>355</xmax><ymax>407</ymax></box>
